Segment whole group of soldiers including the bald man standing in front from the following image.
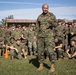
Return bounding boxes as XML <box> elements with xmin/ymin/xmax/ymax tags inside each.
<box><xmin>0</xmin><ymin>4</ymin><xmax>76</xmax><ymax>72</ymax></box>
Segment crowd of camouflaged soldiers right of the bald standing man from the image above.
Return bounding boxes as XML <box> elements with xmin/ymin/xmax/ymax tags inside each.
<box><xmin>55</xmin><ymin>20</ymin><xmax>76</xmax><ymax>58</ymax></box>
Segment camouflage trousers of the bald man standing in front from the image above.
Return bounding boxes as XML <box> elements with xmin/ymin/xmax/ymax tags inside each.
<box><xmin>37</xmin><ymin>37</ymin><xmax>56</xmax><ymax>63</ymax></box>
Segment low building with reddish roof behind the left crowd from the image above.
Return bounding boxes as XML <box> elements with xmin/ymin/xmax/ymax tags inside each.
<box><xmin>6</xmin><ymin>19</ymin><xmax>36</xmax><ymax>27</ymax></box>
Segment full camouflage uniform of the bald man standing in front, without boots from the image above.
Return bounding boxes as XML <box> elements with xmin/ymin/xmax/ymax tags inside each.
<box><xmin>36</xmin><ymin>12</ymin><xmax>57</xmax><ymax>63</ymax></box>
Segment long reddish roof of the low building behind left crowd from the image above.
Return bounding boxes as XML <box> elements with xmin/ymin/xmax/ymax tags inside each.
<box><xmin>6</xmin><ymin>19</ymin><xmax>36</xmax><ymax>23</ymax></box>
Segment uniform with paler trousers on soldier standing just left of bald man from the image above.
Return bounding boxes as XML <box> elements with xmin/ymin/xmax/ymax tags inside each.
<box><xmin>28</xmin><ymin>26</ymin><xmax>37</xmax><ymax>55</ymax></box>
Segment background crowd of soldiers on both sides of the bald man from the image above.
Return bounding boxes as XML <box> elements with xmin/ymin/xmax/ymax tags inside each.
<box><xmin>0</xmin><ymin>19</ymin><xmax>76</xmax><ymax>59</ymax></box>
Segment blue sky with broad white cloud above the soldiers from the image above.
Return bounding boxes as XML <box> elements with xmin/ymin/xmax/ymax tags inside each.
<box><xmin>0</xmin><ymin>0</ymin><xmax>76</xmax><ymax>20</ymax></box>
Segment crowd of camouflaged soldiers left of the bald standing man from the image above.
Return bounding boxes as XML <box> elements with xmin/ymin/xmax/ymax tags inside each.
<box><xmin>0</xmin><ymin>24</ymin><xmax>37</xmax><ymax>59</ymax></box>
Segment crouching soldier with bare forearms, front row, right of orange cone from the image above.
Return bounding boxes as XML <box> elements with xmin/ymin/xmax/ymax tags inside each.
<box><xmin>10</xmin><ymin>39</ymin><xmax>28</xmax><ymax>59</ymax></box>
